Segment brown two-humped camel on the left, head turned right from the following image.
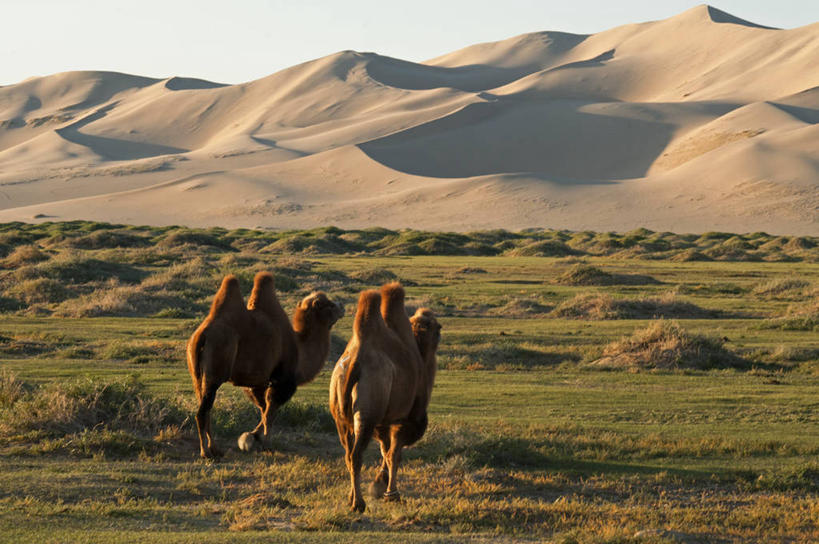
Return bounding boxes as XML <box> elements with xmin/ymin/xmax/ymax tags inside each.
<box><xmin>187</xmin><ymin>272</ymin><xmax>344</xmax><ymax>458</ymax></box>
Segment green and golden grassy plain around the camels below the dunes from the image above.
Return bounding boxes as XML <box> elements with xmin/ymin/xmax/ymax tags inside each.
<box><xmin>0</xmin><ymin>222</ymin><xmax>819</xmax><ymax>543</ymax></box>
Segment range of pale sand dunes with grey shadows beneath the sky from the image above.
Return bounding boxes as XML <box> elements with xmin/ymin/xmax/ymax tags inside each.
<box><xmin>0</xmin><ymin>5</ymin><xmax>819</xmax><ymax>235</ymax></box>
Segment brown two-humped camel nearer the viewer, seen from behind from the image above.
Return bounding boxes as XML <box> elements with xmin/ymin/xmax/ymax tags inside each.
<box><xmin>330</xmin><ymin>283</ymin><xmax>439</xmax><ymax>512</ymax></box>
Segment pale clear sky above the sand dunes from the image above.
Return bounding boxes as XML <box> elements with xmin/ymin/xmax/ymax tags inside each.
<box><xmin>0</xmin><ymin>0</ymin><xmax>819</xmax><ymax>85</ymax></box>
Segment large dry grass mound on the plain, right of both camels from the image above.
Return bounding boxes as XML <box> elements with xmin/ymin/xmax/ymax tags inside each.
<box><xmin>590</xmin><ymin>321</ymin><xmax>745</xmax><ymax>370</ymax></box>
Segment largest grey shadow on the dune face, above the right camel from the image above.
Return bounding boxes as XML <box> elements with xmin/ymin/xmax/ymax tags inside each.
<box><xmin>358</xmin><ymin>99</ymin><xmax>675</xmax><ymax>182</ymax></box>
